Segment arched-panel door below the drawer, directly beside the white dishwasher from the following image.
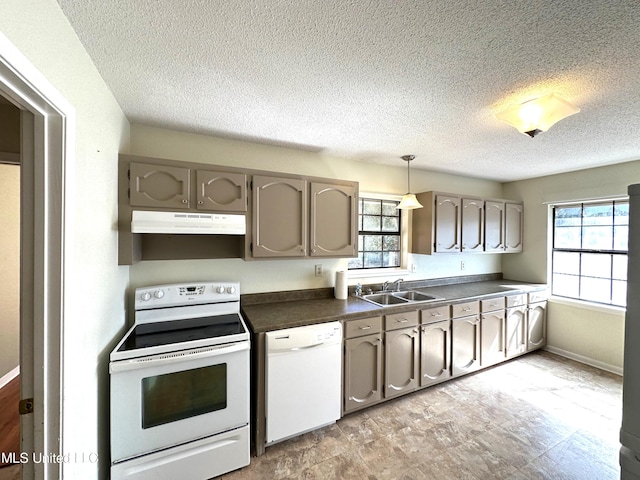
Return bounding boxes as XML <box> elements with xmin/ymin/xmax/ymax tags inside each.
<box><xmin>344</xmin><ymin>334</ymin><xmax>382</xmax><ymax>412</ymax></box>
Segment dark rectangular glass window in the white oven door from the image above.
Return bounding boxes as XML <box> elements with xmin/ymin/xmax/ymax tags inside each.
<box><xmin>142</xmin><ymin>363</ymin><xmax>227</xmax><ymax>428</ymax></box>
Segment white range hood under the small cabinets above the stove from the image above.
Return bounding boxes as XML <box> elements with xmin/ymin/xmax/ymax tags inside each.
<box><xmin>131</xmin><ymin>210</ymin><xmax>246</xmax><ymax>235</ymax></box>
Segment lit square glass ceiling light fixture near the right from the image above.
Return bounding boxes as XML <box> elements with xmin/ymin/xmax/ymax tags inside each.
<box><xmin>496</xmin><ymin>93</ymin><xmax>580</xmax><ymax>138</ymax></box>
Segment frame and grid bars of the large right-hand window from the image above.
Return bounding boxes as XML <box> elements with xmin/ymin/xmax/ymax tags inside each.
<box><xmin>548</xmin><ymin>197</ymin><xmax>629</xmax><ymax>309</ymax></box>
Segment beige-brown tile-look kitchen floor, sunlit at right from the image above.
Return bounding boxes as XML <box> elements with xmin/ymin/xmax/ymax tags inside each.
<box><xmin>220</xmin><ymin>352</ymin><xmax>622</xmax><ymax>480</ymax></box>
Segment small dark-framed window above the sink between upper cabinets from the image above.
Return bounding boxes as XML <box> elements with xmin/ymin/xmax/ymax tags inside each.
<box><xmin>349</xmin><ymin>198</ymin><xmax>401</xmax><ymax>270</ymax></box>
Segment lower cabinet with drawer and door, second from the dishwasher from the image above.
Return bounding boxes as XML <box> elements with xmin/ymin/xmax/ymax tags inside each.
<box><xmin>384</xmin><ymin>311</ymin><xmax>420</xmax><ymax>398</ymax></box>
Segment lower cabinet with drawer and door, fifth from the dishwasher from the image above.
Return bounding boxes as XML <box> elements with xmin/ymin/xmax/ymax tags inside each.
<box><xmin>480</xmin><ymin>297</ymin><xmax>506</xmax><ymax>367</ymax></box>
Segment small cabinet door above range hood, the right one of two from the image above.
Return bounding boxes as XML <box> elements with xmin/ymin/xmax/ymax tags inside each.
<box><xmin>196</xmin><ymin>170</ymin><xmax>247</xmax><ymax>212</ymax></box>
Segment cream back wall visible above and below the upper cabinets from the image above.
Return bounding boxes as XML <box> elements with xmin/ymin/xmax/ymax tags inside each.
<box><xmin>130</xmin><ymin>125</ymin><xmax>502</xmax><ymax>293</ymax></box>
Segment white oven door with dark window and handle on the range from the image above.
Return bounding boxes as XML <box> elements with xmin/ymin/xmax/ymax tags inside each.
<box><xmin>109</xmin><ymin>342</ymin><xmax>250</xmax><ymax>463</ymax></box>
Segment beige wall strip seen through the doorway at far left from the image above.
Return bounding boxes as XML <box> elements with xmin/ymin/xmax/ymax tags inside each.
<box><xmin>0</xmin><ymin>164</ymin><xmax>20</xmax><ymax>378</ymax></box>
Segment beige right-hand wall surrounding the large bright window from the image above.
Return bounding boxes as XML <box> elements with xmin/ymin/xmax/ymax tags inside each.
<box><xmin>503</xmin><ymin>161</ymin><xmax>640</xmax><ymax>372</ymax></box>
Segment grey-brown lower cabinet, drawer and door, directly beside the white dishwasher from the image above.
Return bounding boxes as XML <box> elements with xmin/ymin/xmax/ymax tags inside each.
<box><xmin>343</xmin><ymin>317</ymin><xmax>383</xmax><ymax>413</ymax></box>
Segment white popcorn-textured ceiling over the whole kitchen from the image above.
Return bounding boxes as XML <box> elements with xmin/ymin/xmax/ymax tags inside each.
<box><xmin>58</xmin><ymin>0</ymin><xmax>640</xmax><ymax>181</ymax></box>
